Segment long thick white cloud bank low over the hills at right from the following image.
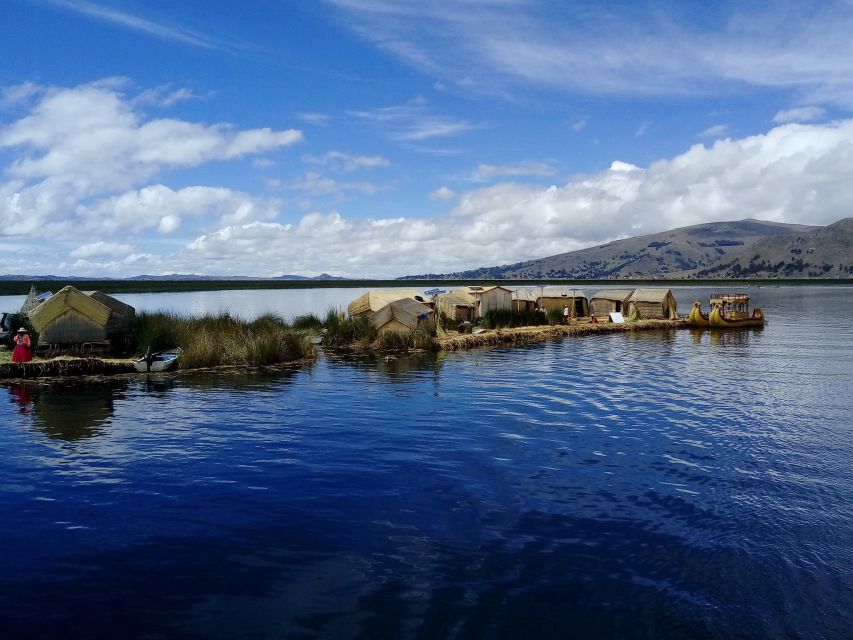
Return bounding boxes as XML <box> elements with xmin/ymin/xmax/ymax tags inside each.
<box><xmin>171</xmin><ymin>120</ymin><xmax>853</xmax><ymax>276</ymax></box>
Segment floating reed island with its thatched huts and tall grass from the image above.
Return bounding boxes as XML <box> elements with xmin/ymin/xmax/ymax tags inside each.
<box><xmin>0</xmin><ymin>286</ymin><xmax>688</xmax><ymax>379</ymax></box>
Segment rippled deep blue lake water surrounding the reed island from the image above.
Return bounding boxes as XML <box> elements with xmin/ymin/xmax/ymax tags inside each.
<box><xmin>0</xmin><ymin>287</ymin><xmax>853</xmax><ymax>639</ymax></box>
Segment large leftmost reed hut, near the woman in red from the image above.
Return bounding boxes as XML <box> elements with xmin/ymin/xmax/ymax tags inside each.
<box><xmin>30</xmin><ymin>286</ymin><xmax>136</xmax><ymax>345</ymax></box>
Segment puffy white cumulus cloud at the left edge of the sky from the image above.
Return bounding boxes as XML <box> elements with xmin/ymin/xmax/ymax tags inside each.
<box><xmin>0</xmin><ymin>79</ymin><xmax>302</xmax><ymax>234</ymax></box>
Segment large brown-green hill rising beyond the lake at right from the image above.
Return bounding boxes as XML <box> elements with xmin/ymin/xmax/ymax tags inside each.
<box><xmin>401</xmin><ymin>218</ymin><xmax>853</xmax><ymax>280</ymax></box>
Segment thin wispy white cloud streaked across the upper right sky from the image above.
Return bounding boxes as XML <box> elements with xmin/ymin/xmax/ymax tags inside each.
<box><xmin>327</xmin><ymin>0</ymin><xmax>853</xmax><ymax>107</ymax></box>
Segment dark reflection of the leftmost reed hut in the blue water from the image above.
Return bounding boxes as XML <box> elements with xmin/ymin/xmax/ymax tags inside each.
<box><xmin>33</xmin><ymin>380</ymin><xmax>128</xmax><ymax>440</ymax></box>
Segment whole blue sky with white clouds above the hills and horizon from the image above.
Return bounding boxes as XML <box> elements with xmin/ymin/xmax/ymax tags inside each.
<box><xmin>0</xmin><ymin>0</ymin><xmax>853</xmax><ymax>278</ymax></box>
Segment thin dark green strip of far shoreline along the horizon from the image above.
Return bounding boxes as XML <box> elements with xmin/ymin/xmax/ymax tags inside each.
<box><xmin>0</xmin><ymin>278</ymin><xmax>853</xmax><ymax>296</ymax></box>
